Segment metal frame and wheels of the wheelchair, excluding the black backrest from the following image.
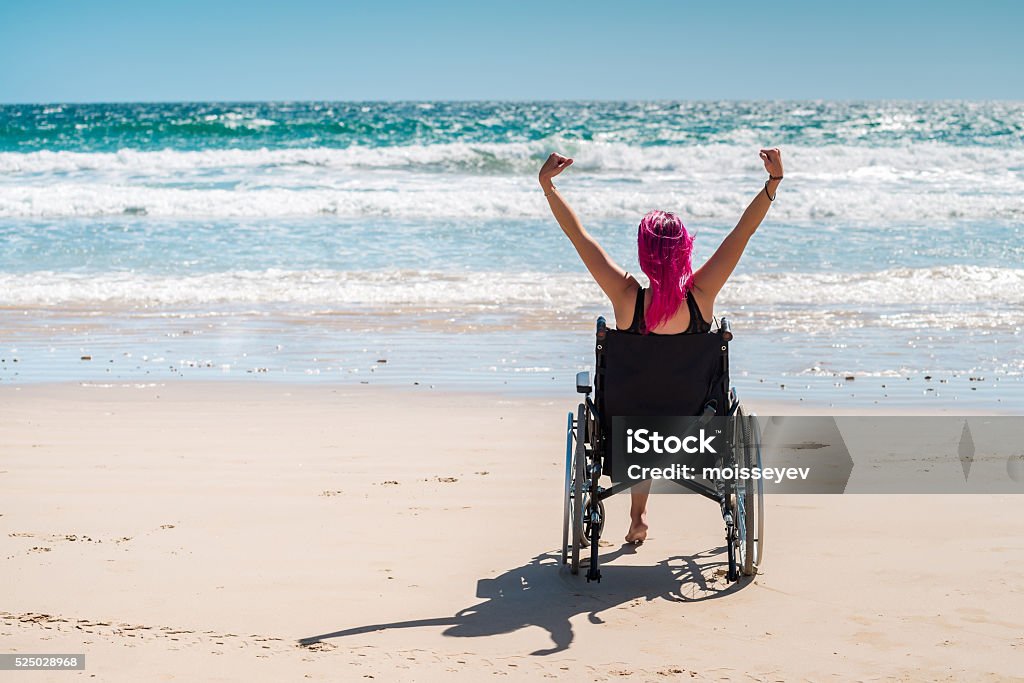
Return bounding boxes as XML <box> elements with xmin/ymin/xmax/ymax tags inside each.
<box><xmin>562</xmin><ymin>317</ymin><xmax>764</xmax><ymax>583</ymax></box>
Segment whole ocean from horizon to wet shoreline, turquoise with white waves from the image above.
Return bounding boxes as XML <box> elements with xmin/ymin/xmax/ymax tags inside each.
<box><xmin>0</xmin><ymin>101</ymin><xmax>1024</xmax><ymax>412</ymax></box>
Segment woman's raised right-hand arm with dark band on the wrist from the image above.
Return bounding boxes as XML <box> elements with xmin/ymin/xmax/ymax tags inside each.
<box><xmin>693</xmin><ymin>148</ymin><xmax>782</xmax><ymax>301</ymax></box>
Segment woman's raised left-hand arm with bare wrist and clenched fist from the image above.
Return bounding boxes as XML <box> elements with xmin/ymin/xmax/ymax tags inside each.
<box><xmin>538</xmin><ymin>154</ymin><xmax>632</xmax><ymax>307</ymax></box>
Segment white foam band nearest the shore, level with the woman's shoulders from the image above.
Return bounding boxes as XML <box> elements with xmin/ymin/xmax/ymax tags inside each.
<box><xmin>0</xmin><ymin>266</ymin><xmax>1024</xmax><ymax>311</ymax></box>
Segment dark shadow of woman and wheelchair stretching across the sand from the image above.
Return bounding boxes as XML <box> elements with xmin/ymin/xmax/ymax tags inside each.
<box><xmin>299</xmin><ymin>545</ymin><xmax>750</xmax><ymax>655</ymax></box>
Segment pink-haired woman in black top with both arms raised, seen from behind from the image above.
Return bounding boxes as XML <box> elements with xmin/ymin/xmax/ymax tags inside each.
<box><xmin>539</xmin><ymin>148</ymin><xmax>782</xmax><ymax>544</ymax></box>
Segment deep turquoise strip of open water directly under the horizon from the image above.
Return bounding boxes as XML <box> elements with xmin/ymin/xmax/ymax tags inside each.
<box><xmin>0</xmin><ymin>101</ymin><xmax>1024</xmax><ymax>151</ymax></box>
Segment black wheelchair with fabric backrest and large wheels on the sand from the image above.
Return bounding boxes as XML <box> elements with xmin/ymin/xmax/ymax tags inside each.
<box><xmin>562</xmin><ymin>317</ymin><xmax>764</xmax><ymax>583</ymax></box>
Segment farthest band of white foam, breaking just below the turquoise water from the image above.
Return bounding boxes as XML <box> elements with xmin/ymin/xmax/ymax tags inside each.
<box><xmin>0</xmin><ymin>140</ymin><xmax>1024</xmax><ymax>178</ymax></box>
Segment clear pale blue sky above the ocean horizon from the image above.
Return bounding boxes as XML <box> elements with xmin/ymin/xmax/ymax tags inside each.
<box><xmin>0</xmin><ymin>0</ymin><xmax>1024</xmax><ymax>102</ymax></box>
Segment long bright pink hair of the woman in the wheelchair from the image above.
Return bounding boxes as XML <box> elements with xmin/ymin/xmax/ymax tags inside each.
<box><xmin>637</xmin><ymin>211</ymin><xmax>693</xmax><ymax>333</ymax></box>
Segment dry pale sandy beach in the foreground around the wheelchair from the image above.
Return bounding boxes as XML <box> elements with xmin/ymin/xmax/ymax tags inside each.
<box><xmin>0</xmin><ymin>382</ymin><xmax>1024</xmax><ymax>681</ymax></box>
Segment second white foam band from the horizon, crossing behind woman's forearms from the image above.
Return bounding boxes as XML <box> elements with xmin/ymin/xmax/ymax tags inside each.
<box><xmin>0</xmin><ymin>176</ymin><xmax>1024</xmax><ymax>226</ymax></box>
